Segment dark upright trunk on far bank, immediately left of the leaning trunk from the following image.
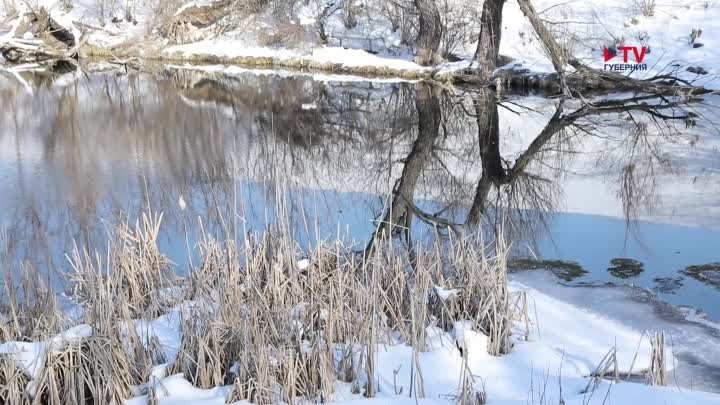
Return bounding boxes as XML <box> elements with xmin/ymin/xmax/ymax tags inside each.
<box><xmin>475</xmin><ymin>0</ymin><xmax>505</xmax><ymax>80</ymax></box>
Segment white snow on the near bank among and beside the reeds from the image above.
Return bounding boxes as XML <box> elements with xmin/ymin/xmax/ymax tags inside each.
<box><xmin>5</xmin><ymin>282</ymin><xmax>720</xmax><ymax>405</ymax></box>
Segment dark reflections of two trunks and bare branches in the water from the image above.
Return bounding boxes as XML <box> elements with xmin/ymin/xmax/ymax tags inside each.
<box><xmin>368</xmin><ymin>80</ymin><xmax>697</xmax><ymax>248</ymax></box>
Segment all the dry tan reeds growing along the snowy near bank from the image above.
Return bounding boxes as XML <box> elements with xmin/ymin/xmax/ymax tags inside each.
<box><xmin>0</xmin><ymin>210</ymin><xmax>511</xmax><ymax>404</ymax></box>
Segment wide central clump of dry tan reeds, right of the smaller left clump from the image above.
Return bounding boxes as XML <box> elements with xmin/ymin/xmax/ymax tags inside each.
<box><xmin>171</xmin><ymin>224</ymin><xmax>510</xmax><ymax>403</ymax></box>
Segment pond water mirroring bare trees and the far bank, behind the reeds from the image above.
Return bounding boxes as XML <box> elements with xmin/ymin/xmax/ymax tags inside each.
<box><xmin>0</xmin><ymin>64</ymin><xmax>712</xmax><ymax>308</ymax></box>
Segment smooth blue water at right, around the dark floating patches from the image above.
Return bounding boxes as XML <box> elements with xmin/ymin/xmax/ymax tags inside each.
<box><xmin>534</xmin><ymin>213</ymin><xmax>720</xmax><ymax>321</ymax></box>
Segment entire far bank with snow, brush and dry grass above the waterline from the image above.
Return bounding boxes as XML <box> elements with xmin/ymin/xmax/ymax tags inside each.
<box><xmin>0</xmin><ymin>0</ymin><xmax>720</xmax><ymax>87</ymax></box>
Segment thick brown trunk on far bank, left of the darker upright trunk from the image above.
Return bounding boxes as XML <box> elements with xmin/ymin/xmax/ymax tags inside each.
<box><xmin>413</xmin><ymin>0</ymin><xmax>442</xmax><ymax>66</ymax></box>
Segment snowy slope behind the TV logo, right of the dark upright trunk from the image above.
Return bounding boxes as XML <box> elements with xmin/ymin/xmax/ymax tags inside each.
<box><xmin>500</xmin><ymin>0</ymin><xmax>720</xmax><ymax>79</ymax></box>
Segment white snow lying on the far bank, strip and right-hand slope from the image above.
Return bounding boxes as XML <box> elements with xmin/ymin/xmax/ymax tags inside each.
<box><xmin>156</xmin><ymin>0</ymin><xmax>720</xmax><ymax>85</ymax></box>
